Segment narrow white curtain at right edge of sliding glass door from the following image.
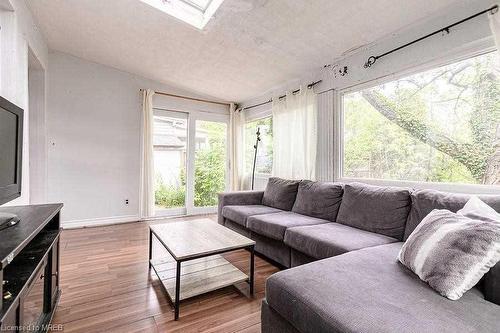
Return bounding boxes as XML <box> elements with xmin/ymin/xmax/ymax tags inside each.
<box><xmin>229</xmin><ymin>103</ymin><xmax>245</xmax><ymax>191</ymax></box>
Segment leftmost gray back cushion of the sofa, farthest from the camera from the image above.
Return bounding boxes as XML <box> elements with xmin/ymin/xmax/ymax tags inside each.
<box><xmin>262</xmin><ymin>177</ymin><xmax>299</xmax><ymax>210</ymax></box>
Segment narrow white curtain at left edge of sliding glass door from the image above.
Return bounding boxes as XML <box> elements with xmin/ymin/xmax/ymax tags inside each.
<box><xmin>140</xmin><ymin>89</ymin><xmax>155</xmax><ymax>218</ymax></box>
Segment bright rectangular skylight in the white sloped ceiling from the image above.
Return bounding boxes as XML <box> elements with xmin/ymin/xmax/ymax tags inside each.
<box><xmin>140</xmin><ymin>0</ymin><xmax>224</xmax><ymax>30</ymax></box>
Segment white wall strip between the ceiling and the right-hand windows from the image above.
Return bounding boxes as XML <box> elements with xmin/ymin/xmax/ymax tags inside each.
<box><xmin>239</xmin><ymin>0</ymin><xmax>498</xmax><ymax>105</ymax></box>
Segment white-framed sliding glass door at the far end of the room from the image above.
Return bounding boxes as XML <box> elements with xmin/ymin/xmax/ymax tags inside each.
<box><xmin>154</xmin><ymin>110</ymin><xmax>229</xmax><ymax>216</ymax></box>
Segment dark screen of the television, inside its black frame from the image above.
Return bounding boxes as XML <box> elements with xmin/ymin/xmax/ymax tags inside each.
<box><xmin>0</xmin><ymin>109</ymin><xmax>18</xmax><ymax>187</ymax></box>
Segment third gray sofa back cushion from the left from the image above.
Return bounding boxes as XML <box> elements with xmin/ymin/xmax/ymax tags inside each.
<box><xmin>337</xmin><ymin>183</ymin><xmax>411</xmax><ymax>240</ymax></box>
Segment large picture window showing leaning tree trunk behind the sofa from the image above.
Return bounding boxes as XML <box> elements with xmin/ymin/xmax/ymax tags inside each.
<box><xmin>342</xmin><ymin>52</ymin><xmax>500</xmax><ymax>185</ymax></box>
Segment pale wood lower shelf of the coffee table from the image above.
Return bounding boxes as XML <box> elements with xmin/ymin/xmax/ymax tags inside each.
<box><xmin>150</xmin><ymin>255</ymin><xmax>248</xmax><ymax>302</ymax></box>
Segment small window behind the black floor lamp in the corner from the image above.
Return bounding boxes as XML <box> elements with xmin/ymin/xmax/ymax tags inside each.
<box><xmin>245</xmin><ymin>117</ymin><xmax>273</xmax><ymax>189</ymax></box>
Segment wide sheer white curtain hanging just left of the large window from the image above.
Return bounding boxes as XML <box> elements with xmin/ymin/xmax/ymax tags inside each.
<box><xmin>272</xmin><ymin>88</ymin><xmax>318</xmax><ymax>180</ymax></box>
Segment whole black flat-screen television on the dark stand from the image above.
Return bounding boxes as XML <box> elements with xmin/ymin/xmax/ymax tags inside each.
<box><xmin>0</xmin><ymin>97</ymin><xmax>23</xmax><ymax>205</ymax></box>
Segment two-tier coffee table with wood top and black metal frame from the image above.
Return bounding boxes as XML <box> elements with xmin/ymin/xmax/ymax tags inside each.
<box><xmin>149</xmin><ymin>219</ymin><xmax>255</xmax><ymax>320</ymax></box>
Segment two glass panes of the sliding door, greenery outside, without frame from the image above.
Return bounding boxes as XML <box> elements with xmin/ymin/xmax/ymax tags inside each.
<box><xmin>154</xmin><ymin>117</ymin><xmax>227</xmax><ymax>209</ymax></box>
